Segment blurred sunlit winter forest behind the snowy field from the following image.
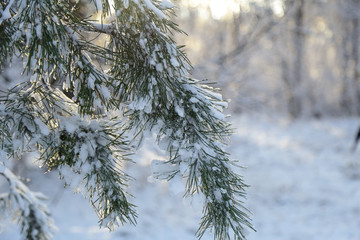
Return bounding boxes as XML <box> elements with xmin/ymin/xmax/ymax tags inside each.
<box><xmin>176</xmin><ymin>0</ymin><xmax>360</xmax><ymax>118</ymax></box>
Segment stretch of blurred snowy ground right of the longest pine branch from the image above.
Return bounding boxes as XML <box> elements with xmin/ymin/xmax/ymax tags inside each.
<box><xmin>231</xmin><ymin>114</ymin><xmax>360</xmax><ymax>240</ymax></box>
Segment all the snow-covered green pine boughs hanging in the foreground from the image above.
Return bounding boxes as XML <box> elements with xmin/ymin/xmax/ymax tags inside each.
<box><xmin>0</xmin><ymin>0</ymin><xmax>252</xmax><ymax>240</ymax></box>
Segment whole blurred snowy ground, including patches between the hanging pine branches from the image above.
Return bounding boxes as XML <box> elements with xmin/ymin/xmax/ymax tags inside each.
<box><xmin>0</xmin><ymin>116</ymin><xmax>360</xmax><ymax>240</ymax></box>
